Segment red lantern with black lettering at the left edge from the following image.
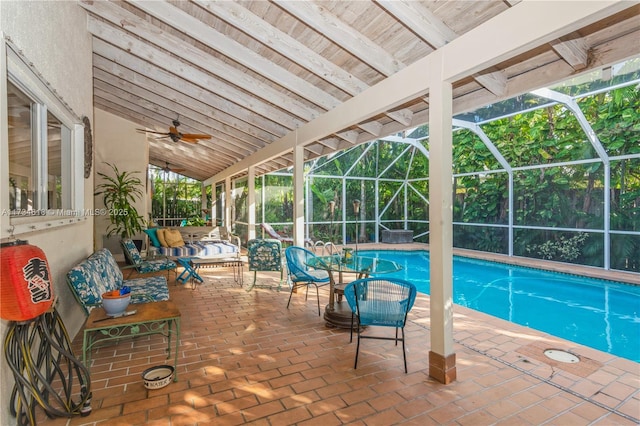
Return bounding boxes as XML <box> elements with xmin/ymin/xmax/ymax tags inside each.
<box><xmin>0</xmin><ymin>241</ymin><xmax>53</xmax><ymax>321</ymax></box>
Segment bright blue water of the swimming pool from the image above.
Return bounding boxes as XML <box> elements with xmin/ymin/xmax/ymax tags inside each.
<box><xmin>358</xmin><ymin>250</ymin><xmax>640</xmax><ymax>362</ymax></box>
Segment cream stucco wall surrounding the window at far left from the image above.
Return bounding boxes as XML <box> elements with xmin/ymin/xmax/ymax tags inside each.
<box><xmin>0</xmin><ymin>0</ymin><xmax>94</xmax><ymax>425</ymax></box>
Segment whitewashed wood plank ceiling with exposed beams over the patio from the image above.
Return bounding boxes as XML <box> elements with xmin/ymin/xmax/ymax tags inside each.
<box><xmin>79</xmin><ymin>0</ymin><xmax>640</xmax><ymax>180</ymax></box>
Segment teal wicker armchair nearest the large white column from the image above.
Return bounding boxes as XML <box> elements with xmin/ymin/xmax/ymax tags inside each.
<box><xmin>344</xmin><ymin>278</ymin><xmax>416</xmax><ymax>373</ymax></box>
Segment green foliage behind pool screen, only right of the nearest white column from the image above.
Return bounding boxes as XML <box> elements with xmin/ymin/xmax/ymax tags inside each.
<box><xmin>453</xmin><ymin>86</ymin><xmax>640</xmax><ymax>271</ymax></box>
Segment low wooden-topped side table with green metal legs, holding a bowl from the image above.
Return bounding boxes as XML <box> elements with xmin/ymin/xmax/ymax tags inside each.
<box><xmin>82</xmin><ymin>300</ymin><xmax>180</xmax><ymax>382</ymax></box>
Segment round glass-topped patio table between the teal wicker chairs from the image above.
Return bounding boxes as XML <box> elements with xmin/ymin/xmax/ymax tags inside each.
<box><xmin>307</xmin><ymin>254</ymin><xmax>402</xmax><ymax>328</ymax></box>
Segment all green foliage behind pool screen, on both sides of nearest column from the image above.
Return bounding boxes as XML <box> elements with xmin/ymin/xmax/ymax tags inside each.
<box><xmin>256</xmin><ymin>85</ymin><xmax>640</xmax><ymax>271</ymax></box>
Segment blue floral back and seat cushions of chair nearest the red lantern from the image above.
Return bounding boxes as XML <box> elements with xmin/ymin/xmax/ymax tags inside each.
<box><xmin>67</xmin><ymin>249</ymin><xmax>170</xmax><ymax>314</ymax></box>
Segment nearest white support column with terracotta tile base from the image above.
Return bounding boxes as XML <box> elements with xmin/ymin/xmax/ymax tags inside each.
<box><xmin>428</xmin><ymin>54</ymin><xmax>456</xmax><ymax>384</ymax></box>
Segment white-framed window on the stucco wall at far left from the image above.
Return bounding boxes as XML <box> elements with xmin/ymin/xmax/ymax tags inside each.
<box><xmin>6</xmin><ymin>42</ymin><xmax>83</xmax><ymax>218</ymax></box>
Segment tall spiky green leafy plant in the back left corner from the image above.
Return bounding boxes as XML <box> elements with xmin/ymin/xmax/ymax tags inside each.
<box><xmin>94</xmin><ymin>163</ymin><xmax>145</xmax><ymax>238</ymax></box>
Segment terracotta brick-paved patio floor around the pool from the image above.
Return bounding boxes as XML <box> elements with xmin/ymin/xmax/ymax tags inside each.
<box><xmin>38</xmin><ymin>245</ymin><xmax>640</xmax><ymax>426</ymax></box>
